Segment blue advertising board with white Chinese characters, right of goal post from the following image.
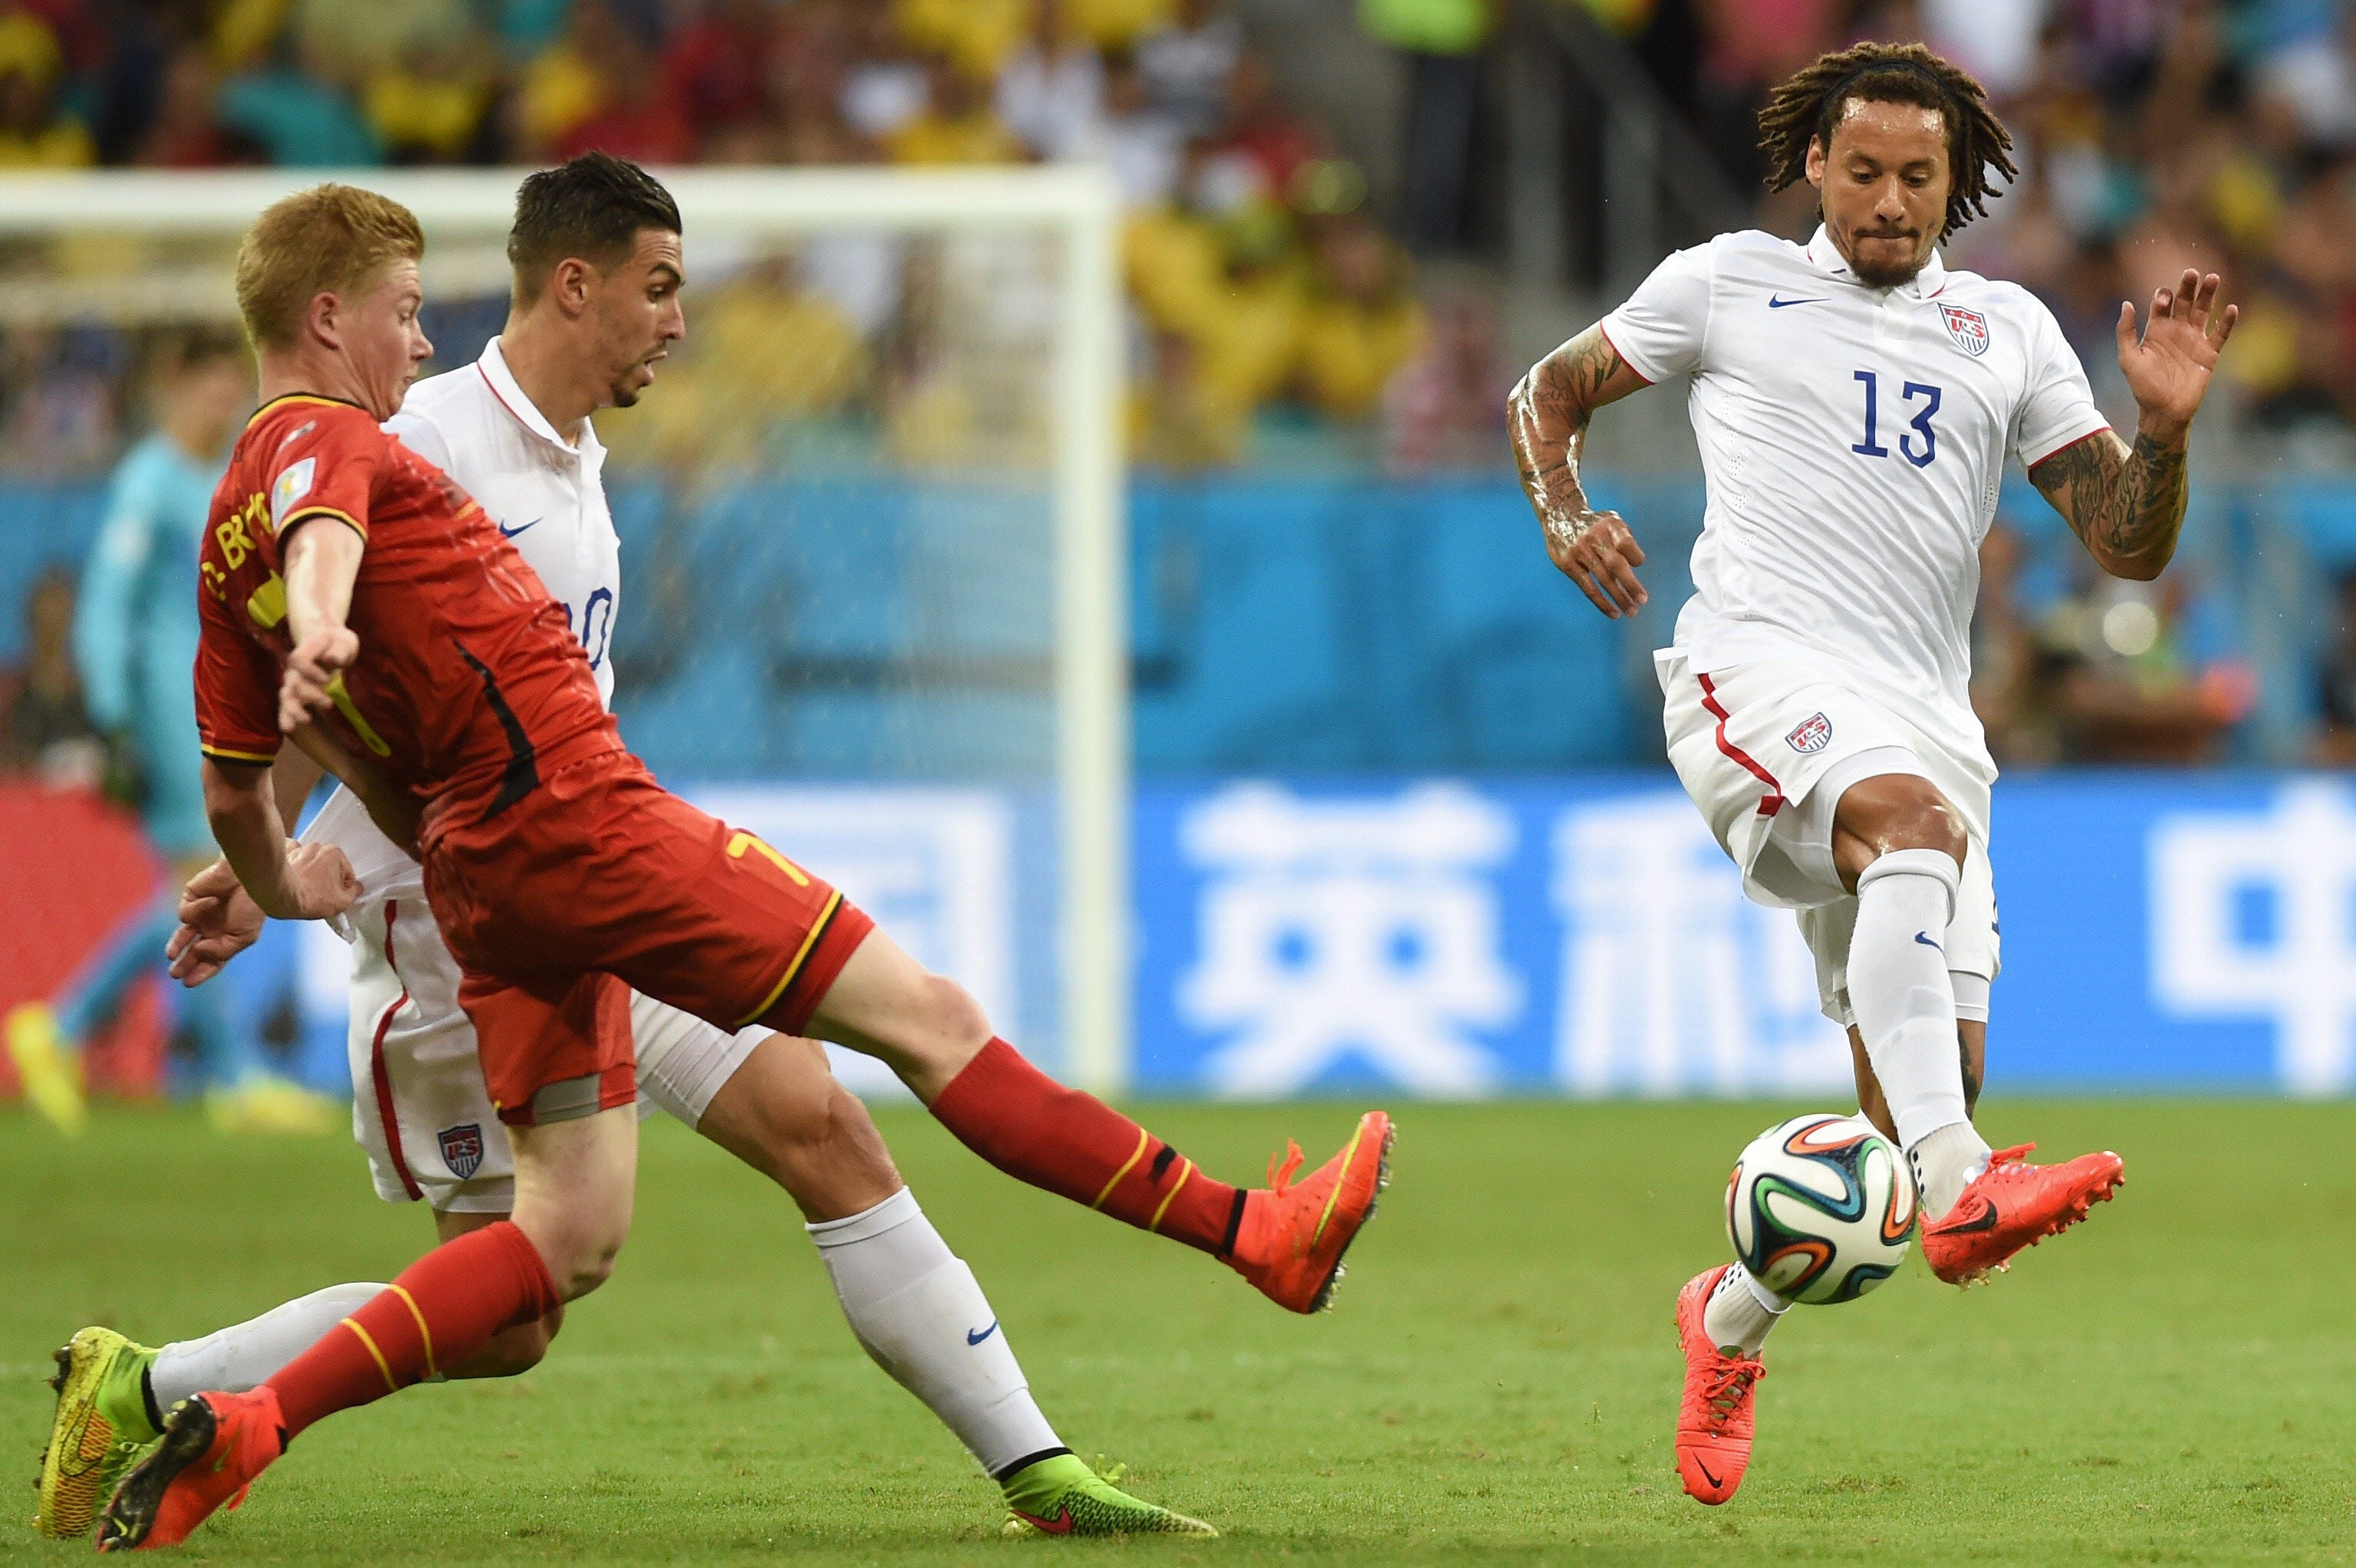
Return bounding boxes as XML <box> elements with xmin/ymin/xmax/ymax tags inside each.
<box><xmin>1134</xmin><ymin>772</ymin><xmax>2356</xmax><ymax>1097</ymax></box>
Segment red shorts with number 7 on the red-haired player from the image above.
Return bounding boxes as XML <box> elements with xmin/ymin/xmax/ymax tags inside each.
<box><xmin>424</xmin><ymin>751</ymin><xmax>874</xmax><ymax>1126</ymax></box>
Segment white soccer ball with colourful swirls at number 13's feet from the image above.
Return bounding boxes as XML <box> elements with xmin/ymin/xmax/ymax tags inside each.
<box><xmin>1727</xmin><ymin>1111</ymin><xmax>1916</xmax><ymax>1304</ymax></box>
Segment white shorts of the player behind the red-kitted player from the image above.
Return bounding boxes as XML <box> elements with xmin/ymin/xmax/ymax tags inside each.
<box><xmin>349</xmin><ymin>897</ymin><xmax>768</xmax><ymax>1215</ymax></box>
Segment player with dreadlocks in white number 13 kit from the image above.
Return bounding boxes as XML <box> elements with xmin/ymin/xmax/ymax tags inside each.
<box><xmin>1510</xmin><ymin>42</ymin><xmax>2236</xmax><ymax>1502</ymax></box>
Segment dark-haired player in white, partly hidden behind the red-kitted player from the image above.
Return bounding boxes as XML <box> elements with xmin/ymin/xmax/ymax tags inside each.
<box><xmin>35</xmin><ymin>153</ymin><xmax>1319</xmax><ymax>1537</ymax></box>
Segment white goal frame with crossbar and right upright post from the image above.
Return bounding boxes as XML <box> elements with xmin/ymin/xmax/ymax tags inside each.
<box><xmin>0</xmin><ymin>165</ymin><xmax>1134</xmax><ymax>1093</ymax></box>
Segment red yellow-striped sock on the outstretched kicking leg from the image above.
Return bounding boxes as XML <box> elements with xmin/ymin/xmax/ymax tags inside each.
<box><xmin>930</xmin><ymin>1040</ymin><xmax>1244</xmax><ymax>1257</ymax></box>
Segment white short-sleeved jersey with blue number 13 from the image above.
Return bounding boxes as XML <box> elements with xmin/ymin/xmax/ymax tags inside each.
<box><xmin>1602</xmin><ymin>228</ymin><xmax>2108</xmax><ymax>779</ymax></box>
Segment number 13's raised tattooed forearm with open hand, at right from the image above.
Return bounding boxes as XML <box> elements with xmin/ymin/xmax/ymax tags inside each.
<box><xmin>2029</xmin><ymin>273</ymin><xmax>2240</xmax><ymax>581</ymax></box>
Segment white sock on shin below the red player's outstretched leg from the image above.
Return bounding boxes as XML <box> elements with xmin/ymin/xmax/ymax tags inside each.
<box><xmin>811</xmin><ymin>1187</ymin><xmax>1062</xmax><ymax>1478</ymax></box>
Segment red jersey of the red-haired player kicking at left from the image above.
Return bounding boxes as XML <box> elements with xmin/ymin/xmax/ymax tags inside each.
<box><xmin>196</xmin><ymin>393</ymin><xmax>622</xmax><ymax>824</ymax></box>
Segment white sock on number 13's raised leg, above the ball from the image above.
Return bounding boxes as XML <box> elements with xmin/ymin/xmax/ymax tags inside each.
<box><xmin>1850</xmin><ymin>850</ymin><xmax>1989</xmax><ymax>1200</ymax></box>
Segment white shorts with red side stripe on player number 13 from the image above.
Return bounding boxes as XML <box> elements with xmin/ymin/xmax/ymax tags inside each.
<box><xmin>1654</xmin><ymin>647</ymin><xmax>2002</xmax><ymax>1027</ymax></box>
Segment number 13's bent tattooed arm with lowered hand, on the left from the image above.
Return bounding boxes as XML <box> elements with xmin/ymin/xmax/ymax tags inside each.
<box><xmin>1505</xmin><ymin>327</ymin><xmax>1647</xmax><ymax>620</ymax></box>
